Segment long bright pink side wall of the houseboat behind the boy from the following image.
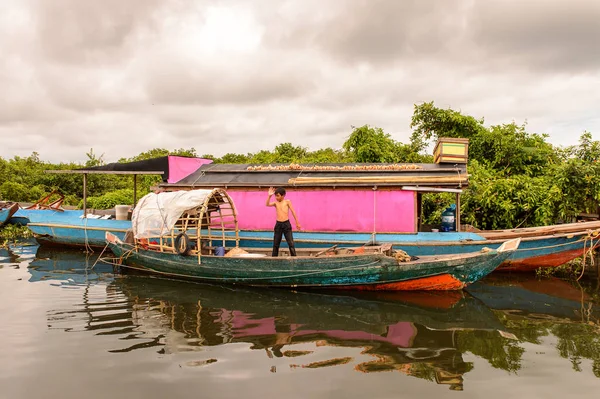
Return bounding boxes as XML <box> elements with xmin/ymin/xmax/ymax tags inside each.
<box><xmin>227</xmin><ymin>189</ymin><xmax>416</xmax><ymax>233</ymax></box>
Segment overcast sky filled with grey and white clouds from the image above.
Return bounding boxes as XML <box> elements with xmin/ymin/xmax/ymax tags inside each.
<box><xmin>0</xmin><ymin>0</ymin><xmax>600</xmax><ymax>162</ymax></box>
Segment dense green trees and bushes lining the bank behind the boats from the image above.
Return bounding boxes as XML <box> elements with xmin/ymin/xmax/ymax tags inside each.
<box><xmin>0</xmin><ymin>102</ymin><xmax>600</xmax><ymax>229</ymax></box>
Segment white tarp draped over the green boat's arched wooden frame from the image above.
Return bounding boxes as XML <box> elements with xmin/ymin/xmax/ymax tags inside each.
<box><xmin>131</xmin><ymin>190</ymin><xmax>217</xmax><ymax>238</ymax></box>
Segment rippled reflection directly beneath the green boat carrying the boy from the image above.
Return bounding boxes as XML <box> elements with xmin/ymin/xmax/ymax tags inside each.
<box><xmin>101</xmin><ymin>275</ymin><xmax>503</xmax><ymax>389</ymax></box>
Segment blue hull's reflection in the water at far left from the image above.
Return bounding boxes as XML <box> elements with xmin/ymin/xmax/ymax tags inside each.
<box><xmin>28</xmin><ymin>246</ymin><xmax>113</xmax><ymax>284</ymax></box>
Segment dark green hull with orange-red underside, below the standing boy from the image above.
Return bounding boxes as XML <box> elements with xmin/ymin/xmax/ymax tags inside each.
<box><xmin>108</xmin><ymin>241</ymin><xmax>512</xmax><ymax>291</ymax></box>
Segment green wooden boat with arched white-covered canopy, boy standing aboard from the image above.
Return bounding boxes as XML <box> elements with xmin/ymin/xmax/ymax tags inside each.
<box><xmin>106</xmin><ymin>189</ymin><xmax>520</xmax><ymax>290</ymax></box>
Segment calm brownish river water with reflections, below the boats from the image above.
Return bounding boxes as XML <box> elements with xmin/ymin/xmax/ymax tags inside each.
<box><xmin>0</xmin><ymin>241</ymin><xmax>600</xmax><ymax>399</ymax></box>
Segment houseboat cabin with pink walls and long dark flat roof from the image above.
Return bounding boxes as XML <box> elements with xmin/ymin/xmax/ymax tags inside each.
<box><xmin>161</xmin><ymin>159</ymin><xmax>469</xmax><ymax>233</ymax></box>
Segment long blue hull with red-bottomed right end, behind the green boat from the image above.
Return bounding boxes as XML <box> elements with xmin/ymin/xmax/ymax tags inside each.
<box><xmin>19</xmin><ymin>210</ymin><xmax>600</xmax><ymax>272</ymax></box>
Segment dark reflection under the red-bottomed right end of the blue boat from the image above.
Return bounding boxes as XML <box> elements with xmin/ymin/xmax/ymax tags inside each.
<box><xmin>468</xmin><ymin>274</ymin><xmax>598</xmax><ymax>321</ymax></box>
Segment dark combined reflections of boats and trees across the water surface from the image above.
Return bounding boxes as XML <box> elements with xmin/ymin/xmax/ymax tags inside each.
<box><xmin>0</xmin><ymin>247</ymin><xmax>600</xmax><ymax>396</ymax></box>
